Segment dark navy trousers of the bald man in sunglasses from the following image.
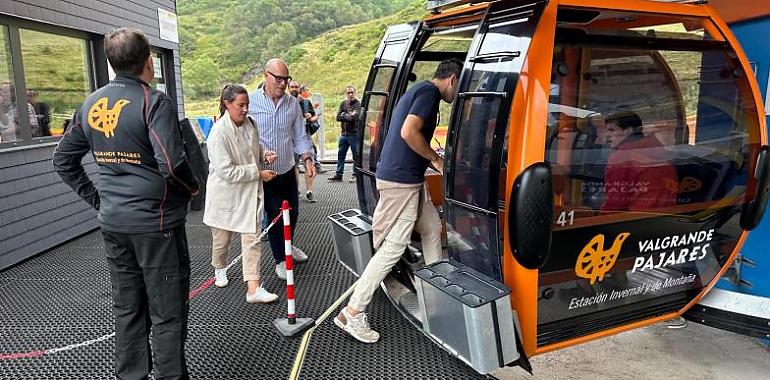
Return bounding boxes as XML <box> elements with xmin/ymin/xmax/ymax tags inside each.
<box><xmin>264</xmin><ymin>168</ymin><xmax>299</xmax><ymax>265</ymax></box>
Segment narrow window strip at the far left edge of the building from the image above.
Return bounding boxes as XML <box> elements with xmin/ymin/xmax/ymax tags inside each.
<box><xmin>0</xmin><ymin>25</ymin><xmax>21</xmax><ymax>142</ymax></box>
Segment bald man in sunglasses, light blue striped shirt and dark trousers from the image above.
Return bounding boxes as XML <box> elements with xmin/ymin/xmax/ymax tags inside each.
<box><xmin>249</xmin><ymin>58</ymin><xmax>315</xmax><ymax>280</ymax></box>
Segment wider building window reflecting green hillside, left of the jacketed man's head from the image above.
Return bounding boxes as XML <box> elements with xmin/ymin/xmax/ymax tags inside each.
<box><xmin>19</xmin><ymin>29</ymin><xmax>92</xmax><ymax>137</ymax></box>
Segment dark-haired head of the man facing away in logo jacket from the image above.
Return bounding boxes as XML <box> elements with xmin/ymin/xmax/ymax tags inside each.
<box><xmin>104</xmin><ymin>28</ymin><xmax>150</xmax><ymax>76</ymax></box>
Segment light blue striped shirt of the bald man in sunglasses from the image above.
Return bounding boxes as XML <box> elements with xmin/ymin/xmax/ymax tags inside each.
<box><xmin>249</xmin><ymin>89</ymin><xmax>313</xmax><ymax>174</ymax></box>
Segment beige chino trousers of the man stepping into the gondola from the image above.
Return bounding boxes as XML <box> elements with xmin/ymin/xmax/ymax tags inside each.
<box><xmin>348</xmin><ymin>179</ymin><xmax>441</xmax><ymax>311</ymax></box>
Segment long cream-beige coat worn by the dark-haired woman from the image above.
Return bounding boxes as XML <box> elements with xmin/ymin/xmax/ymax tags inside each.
<box><xmin>203</xmin><ymin>112</ymin><xmax>264</xmax><ymax>233</ymax></box>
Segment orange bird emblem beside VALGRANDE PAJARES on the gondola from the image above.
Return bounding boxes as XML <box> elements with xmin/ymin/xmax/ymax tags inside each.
<box><xmin>575</xmin><ymin>232</ymin><xmax>631</xmax><ymax>285</ymax></box>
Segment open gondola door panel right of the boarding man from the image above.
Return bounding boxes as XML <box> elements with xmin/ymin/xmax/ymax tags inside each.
<box><xmin>444</xmin><ymin>2</ymin><xmax>543</xmax><ymax>280</ymax></box>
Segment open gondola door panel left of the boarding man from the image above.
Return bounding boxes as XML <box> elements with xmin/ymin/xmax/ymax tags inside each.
<box><xmin>354</xmin><ymin>22</ymin><xmax>421</xmax><ymax>216</ymax></box>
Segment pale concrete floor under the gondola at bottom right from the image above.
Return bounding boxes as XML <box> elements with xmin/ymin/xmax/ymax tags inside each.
<box><xmin>494</xmin><ymin>322</ymin><xmax>770</xmax><ymax>380</ymax></box>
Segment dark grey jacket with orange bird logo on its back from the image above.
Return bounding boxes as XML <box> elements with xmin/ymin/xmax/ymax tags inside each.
<box><xmin>53</xmin><ymin>75</ymin><xmax>198</xmax><ymax>233</ymax></box>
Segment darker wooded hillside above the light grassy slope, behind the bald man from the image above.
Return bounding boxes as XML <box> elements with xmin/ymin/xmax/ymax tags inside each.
<box><xmin>177</xmin><ymin>0</ymin><xmax>411</xmax><ymax>99</ymax></box>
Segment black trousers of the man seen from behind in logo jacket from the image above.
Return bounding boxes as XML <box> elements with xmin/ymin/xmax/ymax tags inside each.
<box><xmin>102</xmin><ymin>225</ymin><xmax>190</xmax><ymax>379</ymax></box>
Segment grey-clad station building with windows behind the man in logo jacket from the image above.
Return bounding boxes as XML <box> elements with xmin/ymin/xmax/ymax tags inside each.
<box><xmin>0</xmin><ymin>0</ymin><xmax>184</xmax><ymax>270</ymax></box>
